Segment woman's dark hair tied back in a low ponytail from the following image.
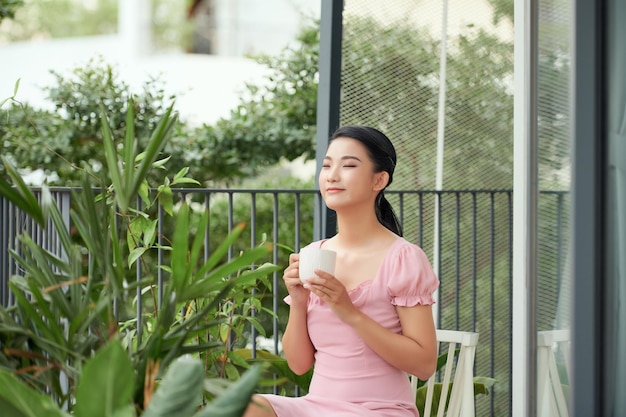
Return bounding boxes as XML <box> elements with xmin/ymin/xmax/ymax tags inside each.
<box><xmin>328</xmin><ymin>126</ymin><xmax>402</xmax><ymax>236</ymax></box>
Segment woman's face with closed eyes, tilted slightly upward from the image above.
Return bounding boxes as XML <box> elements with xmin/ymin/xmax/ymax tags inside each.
<box><xmin>319</xmin><ymin>137</ymin><xmax>389</xmax><ymax>210</ymax></box>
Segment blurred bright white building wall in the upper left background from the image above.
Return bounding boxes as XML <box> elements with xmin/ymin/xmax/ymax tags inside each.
<box><xmin>0</xmin><ymin>0</ymin><xmax>320</xmax><ymax>124</ymax></box>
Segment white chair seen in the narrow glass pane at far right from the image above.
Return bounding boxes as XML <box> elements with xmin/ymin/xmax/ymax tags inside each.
<box><xmin>537</xmin><ymin>330</ymin><xmax>570</xmax><ymax>417</ymax></box>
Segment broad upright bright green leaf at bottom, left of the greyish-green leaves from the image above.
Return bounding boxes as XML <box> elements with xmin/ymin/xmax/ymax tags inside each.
<box><xmin>74</xmin><ymin>340</ymin><xmax>135</xmax><ymax>417</ymax></box>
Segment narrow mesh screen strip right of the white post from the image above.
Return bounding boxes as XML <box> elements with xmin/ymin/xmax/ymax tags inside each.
<box><xmin>536</xmin><ymin>0</ymin><xmax>572</xmax><ymax>412</ymax></box>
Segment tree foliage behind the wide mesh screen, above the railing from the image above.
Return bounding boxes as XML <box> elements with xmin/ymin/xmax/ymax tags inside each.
<box><xmin>341</xmin><ymin>17</ymin><xmax>513</xmax><ymax>189</ymax></box>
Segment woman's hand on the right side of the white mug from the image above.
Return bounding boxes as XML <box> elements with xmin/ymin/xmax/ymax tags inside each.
<box><xmin>304</xmin><ymin>269</ymin><xmax>362</xmax><ymax>325</ymax></box>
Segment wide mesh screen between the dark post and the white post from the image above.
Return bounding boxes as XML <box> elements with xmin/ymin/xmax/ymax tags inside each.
<box><xmin>340</xmin><ymin>0</ymin><xmax>513</xmax><ymax>416</ymax></box>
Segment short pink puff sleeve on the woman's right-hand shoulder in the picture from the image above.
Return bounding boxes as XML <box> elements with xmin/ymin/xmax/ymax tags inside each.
<box><xmin>387</xmin><ymin>242</ymin><xmax>439</xmax><ymax>307</ymax></box>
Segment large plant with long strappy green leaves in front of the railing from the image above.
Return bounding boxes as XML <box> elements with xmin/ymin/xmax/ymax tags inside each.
<box><xmin>0</xmin><ymin>99</ymin><xmax>278</xmax><ymax>417</ymax></box>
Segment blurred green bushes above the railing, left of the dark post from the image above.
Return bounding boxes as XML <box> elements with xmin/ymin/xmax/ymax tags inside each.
<box><xmin>0</xmin><ymin>21</ymin><xmax>318</xmax><ymax>185</ymax></box>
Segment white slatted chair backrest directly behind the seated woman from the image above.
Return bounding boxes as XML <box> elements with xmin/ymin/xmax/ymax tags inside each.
<box><xmin>411</xmin><ymin>330</ymin><xmax>478</xmax><ymax>417</ymax></box>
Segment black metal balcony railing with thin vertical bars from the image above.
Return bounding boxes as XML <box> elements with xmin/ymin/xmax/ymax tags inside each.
<box><xmin>0</xmin><ymin>188</ymin><xmax>569</xmax><ymax>415</ymax></box>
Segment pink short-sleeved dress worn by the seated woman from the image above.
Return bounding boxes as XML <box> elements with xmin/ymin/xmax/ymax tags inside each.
<box><xmin>264</xmin><ymin>238</ymin><xmax>439</xmax><ymax>417</ymax></box>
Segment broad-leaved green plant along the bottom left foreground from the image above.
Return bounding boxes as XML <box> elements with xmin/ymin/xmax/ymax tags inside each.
<box><xmin>0</xmin><ymin>341</ymin><xmax>260</xmax><ymax>417</ymax></box>
